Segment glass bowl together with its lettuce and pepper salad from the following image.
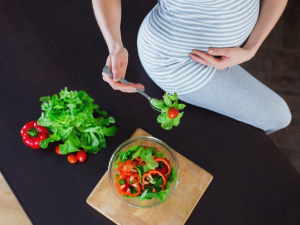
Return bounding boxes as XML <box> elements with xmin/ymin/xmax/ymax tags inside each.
<box><xmin>109</xmin><ymin>136</ymin><xmax>180</xmax><ymax>208</ymax></box>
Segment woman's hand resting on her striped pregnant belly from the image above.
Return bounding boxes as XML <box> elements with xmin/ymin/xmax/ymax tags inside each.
<box><xmin>189</xmin><ymin>47</ymin><xmax>254</xmax><ymax>70</ymax></box>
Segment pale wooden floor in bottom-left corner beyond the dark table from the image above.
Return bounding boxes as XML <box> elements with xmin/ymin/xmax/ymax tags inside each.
<box><xmin>0</xmin><ymin>173</ymin><xmax>31</xmax><ymax>225</ymax></box>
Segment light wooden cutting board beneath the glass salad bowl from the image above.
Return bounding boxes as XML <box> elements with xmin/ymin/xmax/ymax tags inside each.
<box><xmin>87</xmin><ymin>128</ymin><xmax>213</xmax><ymax>225</ymax></box>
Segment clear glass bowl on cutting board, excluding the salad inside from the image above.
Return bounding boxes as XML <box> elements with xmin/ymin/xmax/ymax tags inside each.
<box><xmin>108</xmin><ymin>136</ymin><xmax>180</xmax><ymax>208</ymax></box>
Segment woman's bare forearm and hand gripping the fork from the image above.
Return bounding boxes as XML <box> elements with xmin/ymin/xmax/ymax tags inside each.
<box><xmin>92</xmin><ymin>0</ymin><xmax>144</xmax><ymax>92</ymax></box>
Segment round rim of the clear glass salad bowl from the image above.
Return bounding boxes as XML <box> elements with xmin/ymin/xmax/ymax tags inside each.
<box><xmin>108</xmin><ymin>136</ymin><xmax>180</xmax><ymax>209</ymax></box>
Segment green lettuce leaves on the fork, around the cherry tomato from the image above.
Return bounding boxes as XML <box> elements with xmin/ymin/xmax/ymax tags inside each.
<box><xmin>150</xmin><ymin>92</ymin><xmax>185</xmax><ymax>130</ymax></box>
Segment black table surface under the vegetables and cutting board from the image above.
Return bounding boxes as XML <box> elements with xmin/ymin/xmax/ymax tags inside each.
<box><xmin>0</xmin><ymin>0</ymin><xmax>300</xmax><ymax>225</ymax></box>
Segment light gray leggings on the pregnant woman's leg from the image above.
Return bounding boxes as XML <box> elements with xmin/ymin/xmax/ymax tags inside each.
<box><xmin>179</xmin><ymin>66</ymin><xmax>292</xmax><ymax>134</ymax></box>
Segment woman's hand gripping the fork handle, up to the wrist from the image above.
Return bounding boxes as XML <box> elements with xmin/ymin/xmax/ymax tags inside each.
<box><xmin>102</xmin><ymin>46</ymin><xmax>145</xmax><ymax>93</ymax></box>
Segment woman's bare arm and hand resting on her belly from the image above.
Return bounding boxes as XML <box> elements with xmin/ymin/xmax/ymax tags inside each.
<box><xmin>189</xmin><ymin>0</ymin><xmax>288</xmax><ymax>69</ymax></box>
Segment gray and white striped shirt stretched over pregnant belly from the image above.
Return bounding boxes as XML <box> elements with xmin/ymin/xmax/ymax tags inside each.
<box><xmin>138</xmin><ymin>0</ymin><xmax>259</xmax><ymax>94</ymax></box>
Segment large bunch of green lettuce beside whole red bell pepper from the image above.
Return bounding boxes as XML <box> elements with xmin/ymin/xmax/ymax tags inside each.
<box><xmin>37</xmin><ymin>88</ymin><xmax>117</xmax><ymax>154</ymax></box>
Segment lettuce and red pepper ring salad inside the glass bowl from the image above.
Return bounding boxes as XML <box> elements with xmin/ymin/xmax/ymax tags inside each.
<box><xmin>115</xmin><ymin>145</ymin><xmax>177</xmax><ymax>201</ymax></box>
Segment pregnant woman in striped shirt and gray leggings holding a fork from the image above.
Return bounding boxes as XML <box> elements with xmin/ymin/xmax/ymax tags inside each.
<box><xmin>93</xmin><ymin>0</ymin><xmax>291</xmax><ymax>134</ymax></box>
